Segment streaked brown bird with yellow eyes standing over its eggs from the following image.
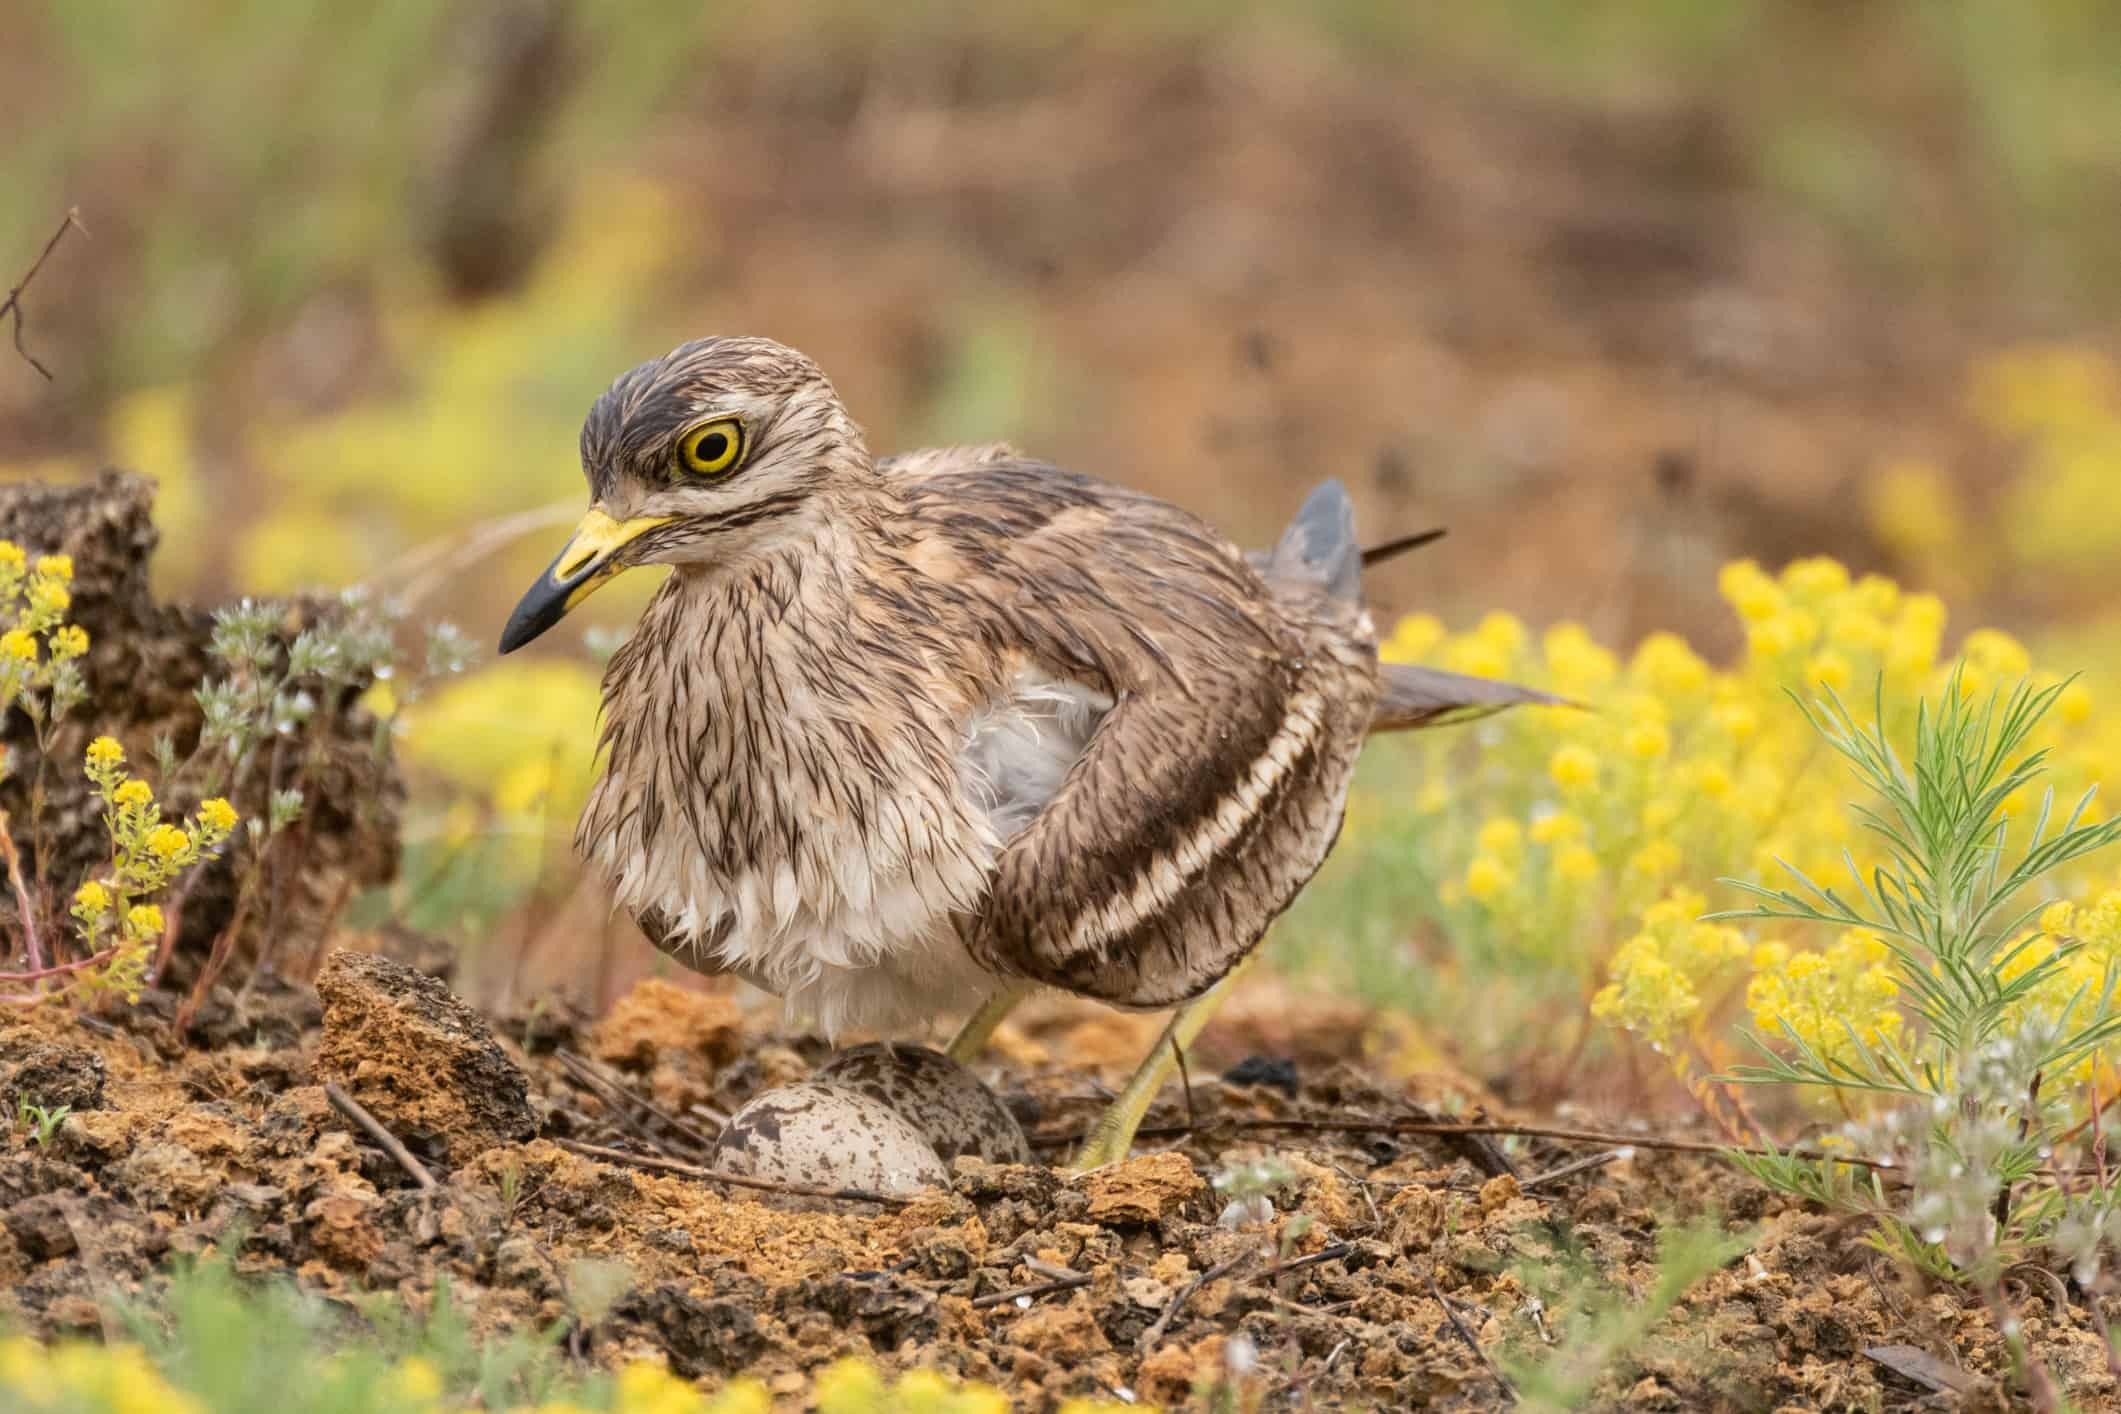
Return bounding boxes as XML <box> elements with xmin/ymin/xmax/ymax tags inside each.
<box><xmin>498</xmin><ymin>337</ymin><xmax>1555</xmax><ymax>1168</ymax></box>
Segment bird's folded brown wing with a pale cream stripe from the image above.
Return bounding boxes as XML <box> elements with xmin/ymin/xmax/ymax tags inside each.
<box><xmin>921</xmin><ymin>462</ymin><xmax>1377</xmax><ymax>1007</ymax></box>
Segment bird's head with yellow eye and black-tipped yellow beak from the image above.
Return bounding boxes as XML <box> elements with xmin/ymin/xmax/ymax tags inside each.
<box><xmin>501</xmin><ymin>339</ymin><xmax>867</xmax><ymax>653</ymax></box>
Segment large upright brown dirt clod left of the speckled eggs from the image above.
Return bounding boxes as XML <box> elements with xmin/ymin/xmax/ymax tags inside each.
<box><xmin>316</xmin><ymin>952</ymin><xmax>537</xmax><ymax>1164</ymax></box>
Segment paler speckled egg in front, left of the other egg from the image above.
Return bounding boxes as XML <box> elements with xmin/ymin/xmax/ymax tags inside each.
<box><xmin>706</xmin><ymin>1079</ymin><xmax>950</xmax><ymax>1194</ymax></box>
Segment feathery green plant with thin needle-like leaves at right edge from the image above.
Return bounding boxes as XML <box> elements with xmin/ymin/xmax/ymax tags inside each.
<box><xmin>1718</xmin><ymin>674</ymin><xmax>2121</xmax><ymax>1285</ymax></box>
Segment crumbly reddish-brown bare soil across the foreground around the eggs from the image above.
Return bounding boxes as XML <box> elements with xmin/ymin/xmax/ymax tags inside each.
<box><xmin>0</xmin><ymin>952</ymin><xmax>2115</xmax><ymax>1410</ymax></box>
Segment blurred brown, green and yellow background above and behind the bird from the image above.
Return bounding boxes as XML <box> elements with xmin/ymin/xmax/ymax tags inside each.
<box><xmin>0</xmin><ymin>0</ymin><xmax>2121</xmax><ymax>1068</ymax></box>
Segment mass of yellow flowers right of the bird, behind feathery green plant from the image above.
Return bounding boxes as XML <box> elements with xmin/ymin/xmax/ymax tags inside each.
<box><xmin>1285</xmin><ymin>558</ymin><xmax>2121</xmax><ymax>1143</ymax></box>
